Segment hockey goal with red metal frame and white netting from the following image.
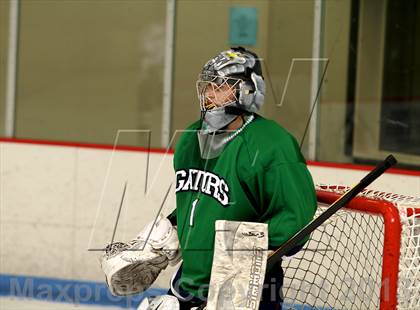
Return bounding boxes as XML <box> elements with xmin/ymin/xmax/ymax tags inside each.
<box><xmin>282</xmin><ymin>185</ymin><xmax>420</xmax><ymax>310</ymax></box>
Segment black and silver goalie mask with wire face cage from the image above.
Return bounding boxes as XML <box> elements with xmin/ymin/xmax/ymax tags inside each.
<box><xmin>197</xmin><ymin>47</ymin><xmax>265</xmax><ymax>133</ymax></box>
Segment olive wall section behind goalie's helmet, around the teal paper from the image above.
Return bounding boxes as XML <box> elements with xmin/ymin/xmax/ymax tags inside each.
<box><xmin>172</xmin><ymin>0</ymin><xmax>269</xmax><ymax>142</ymax></box>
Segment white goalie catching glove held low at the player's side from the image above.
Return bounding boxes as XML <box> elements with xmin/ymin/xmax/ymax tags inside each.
<box><xmin>100</xmin><ymin>216</ymin><xmax>181</xmax><ymax>296</ymax></box>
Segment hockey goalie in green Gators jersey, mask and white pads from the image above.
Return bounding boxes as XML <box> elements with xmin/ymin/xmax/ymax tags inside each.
<box><xmin>101</xmin><ymin>47</ymin><xmax>317</xmax><ymax>310</ymax></box>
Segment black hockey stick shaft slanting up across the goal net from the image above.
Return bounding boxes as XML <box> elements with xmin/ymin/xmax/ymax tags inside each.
<box><xmin>267</xmin><ymin>155</ymin><xmax>397</xmax><ymax>270</ymax></box>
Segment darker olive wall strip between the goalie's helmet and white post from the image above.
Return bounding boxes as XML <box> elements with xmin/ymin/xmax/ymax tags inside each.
<box><xmin>264</xmin><ymin>1</ymin><xmax>314</xmax><ymax>153</ymax></box>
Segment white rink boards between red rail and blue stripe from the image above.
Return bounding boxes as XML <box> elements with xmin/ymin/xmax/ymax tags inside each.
<box><xmin>0</xmin><ymin>142</ymin><xmax>420</xmax><ymax>287</ymax></box>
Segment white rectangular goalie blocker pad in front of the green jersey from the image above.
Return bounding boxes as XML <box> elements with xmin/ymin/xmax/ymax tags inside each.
<box><xmin>206</xmin><ymin>221</ymin><xmax>268</xmax><ymax>310</ymax></box>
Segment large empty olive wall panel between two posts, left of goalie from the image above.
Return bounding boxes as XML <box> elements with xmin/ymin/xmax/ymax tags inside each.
<box><xmin>16</xmin><ymin>1</ymin><xmax>166</xmax><ymax>145</ymax></box>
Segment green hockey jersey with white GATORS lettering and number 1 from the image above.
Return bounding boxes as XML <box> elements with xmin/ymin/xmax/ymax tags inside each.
<box><xmin>174</xmin><ymin>115</ymin><xmax>316</xmax><ymax>297</ymax></box>
